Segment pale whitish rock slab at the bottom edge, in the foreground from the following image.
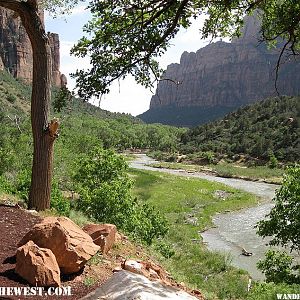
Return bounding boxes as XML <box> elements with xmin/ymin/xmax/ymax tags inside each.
<box><xmin>81</xmin><ymin>270</ymin><xmax>197</xmax><ymax>300</ymax></box>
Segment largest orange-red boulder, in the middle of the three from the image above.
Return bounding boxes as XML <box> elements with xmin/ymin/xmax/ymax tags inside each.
<box><xmin>19</xmin><ymin>217</ymin><xmax>100</xmax><ymax>274</ymax></box>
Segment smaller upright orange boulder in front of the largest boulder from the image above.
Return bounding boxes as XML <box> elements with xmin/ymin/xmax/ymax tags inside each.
<box><xmin>15</xmin><ymin>241</ymin><xmax>60</xmax><ymax>286</ymax></box>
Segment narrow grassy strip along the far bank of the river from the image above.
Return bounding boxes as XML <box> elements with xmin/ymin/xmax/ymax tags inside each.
<box><xmin>151</xmin><ymin>162</ymin><xmax>284</xmax><ymax>184</ymax></box>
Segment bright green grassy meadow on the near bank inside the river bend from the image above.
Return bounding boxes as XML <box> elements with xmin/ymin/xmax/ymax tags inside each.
<box><xmin>131</xmin><ymin>170</ymin><xmax>258</xmax><ymax>299</ymax></box>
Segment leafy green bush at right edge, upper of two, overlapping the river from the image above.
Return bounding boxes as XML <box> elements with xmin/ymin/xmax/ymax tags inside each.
<box><xmin>257</xmin><ymin>164</ymin><xmax>300</xmax><ymax>251</ymax></box>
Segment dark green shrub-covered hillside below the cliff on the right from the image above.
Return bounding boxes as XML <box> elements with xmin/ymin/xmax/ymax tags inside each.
<box><xmin>181</xmin><ymin>96</ymin><xmax>300</xmax><ymax>161</ymax></box>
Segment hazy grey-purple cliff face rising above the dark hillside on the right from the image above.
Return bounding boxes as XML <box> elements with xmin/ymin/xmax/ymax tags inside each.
<box><xmin>140</xmin><ymin>17</ymin><xmax>300</xmax><ymax>125</ymax></box>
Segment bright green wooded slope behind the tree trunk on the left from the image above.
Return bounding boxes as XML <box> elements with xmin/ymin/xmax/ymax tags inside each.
<box><xmin>0</xmin><ymin>72</ymin><xmax>186</xmax><ymax>188</ymax></box>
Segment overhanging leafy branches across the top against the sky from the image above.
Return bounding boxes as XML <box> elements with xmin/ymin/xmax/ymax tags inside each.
<box><xmin>71</xmin><ymin>0</ymin><xmax>300</xmax><ymax>98</ymax></box>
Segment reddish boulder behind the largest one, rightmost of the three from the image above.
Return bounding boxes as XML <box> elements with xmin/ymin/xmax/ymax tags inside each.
<box><xmin>83</xmin><ymin>224</ymin><xmax>117</xmax><ymax>254</ymax></box>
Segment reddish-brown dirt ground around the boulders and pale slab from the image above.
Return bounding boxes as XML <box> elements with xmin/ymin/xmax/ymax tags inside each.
<box><xmin>0</xmin><ymin>204</ymin><xmax>203</xmax><ymax>300</ymax></box>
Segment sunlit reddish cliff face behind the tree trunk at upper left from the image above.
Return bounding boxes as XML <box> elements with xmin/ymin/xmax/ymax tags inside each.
<box><xmin>0</xmin><ymin>8</ymin><xmax>61</xmax><ymax>87</ymax></box>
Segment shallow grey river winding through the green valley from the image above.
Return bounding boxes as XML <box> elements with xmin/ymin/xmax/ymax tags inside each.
<box><xmin>130</xmin><ymin>154</ymin><xmax>279</xmax><ymax>280</ymax></box>
